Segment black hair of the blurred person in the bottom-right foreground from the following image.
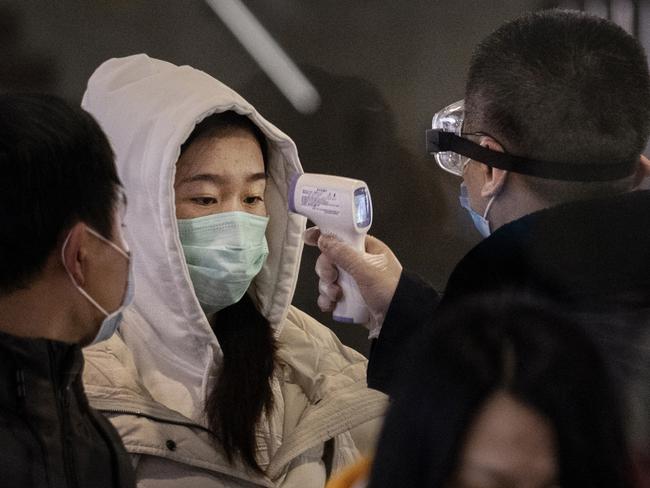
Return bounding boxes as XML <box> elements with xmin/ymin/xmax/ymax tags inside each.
<box><xmin>369</xmin><ymin>293</ymin><xmax>631</xmax><ymax>488</ymax></box>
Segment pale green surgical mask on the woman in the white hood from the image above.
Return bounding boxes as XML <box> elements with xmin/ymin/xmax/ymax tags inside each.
<box><xmin>178</xmin><ymin>212</ymin><xmax>269</xmax><ymax>315</ymax></box>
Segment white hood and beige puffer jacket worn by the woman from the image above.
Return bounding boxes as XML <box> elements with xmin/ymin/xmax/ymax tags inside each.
<box><xmin>82</xmin><ymin>55</ymin><xmax>386</xmax><ymax>488</ymax></box>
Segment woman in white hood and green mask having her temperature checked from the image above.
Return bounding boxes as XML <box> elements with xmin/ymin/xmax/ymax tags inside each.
<box><xmin>82</xmin><ymin>55</ymin><xmax>385</xmax><ymax>488</ymax></box>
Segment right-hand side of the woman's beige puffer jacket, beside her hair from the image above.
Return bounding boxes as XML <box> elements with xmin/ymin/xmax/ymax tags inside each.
<box><xmin>269</xmin><ymin>307</ymin><xmax>387</xmax><ymax>486</ymax></box>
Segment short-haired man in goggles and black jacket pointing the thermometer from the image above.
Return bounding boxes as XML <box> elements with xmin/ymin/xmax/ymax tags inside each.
<box><xmin>305</xmin><ymin>10</ymin><xmax>650</xmax><ymax>466</ymax></box>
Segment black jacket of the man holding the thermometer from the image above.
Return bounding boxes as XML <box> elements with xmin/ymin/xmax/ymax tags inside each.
<box><xmin>368</xmin><ymin>191</ymin><xmax>650</xmax><ymax>392</ymax></box>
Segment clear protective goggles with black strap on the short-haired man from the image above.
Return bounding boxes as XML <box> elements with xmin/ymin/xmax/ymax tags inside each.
<box><xmin>426</xmin><ymin>100</ymin><xmax>637</xmax><ymax>181</ymax></box>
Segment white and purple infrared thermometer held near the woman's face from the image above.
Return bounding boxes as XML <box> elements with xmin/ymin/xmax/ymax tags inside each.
<box><xmin>289</xmin><ymin>173</ymin><xmax>372</xmax><ymax>324</ymax></box>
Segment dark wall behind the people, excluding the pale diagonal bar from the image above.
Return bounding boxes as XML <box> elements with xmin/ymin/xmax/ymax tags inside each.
<box><xmin>0</xmin><ymin>0</ymin><xmax>650</xmax><ymax>353</ymax></box>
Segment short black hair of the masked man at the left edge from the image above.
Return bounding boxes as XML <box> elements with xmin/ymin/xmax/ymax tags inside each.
<box><xmin>0</xmin><ymin>94</ymin><xmax>120</xmax><ymax>293</ymax></box>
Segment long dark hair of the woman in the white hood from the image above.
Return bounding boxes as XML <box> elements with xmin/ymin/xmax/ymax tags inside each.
<box><xmin>181</xmin><ymin>111</ymin><xmax>276</xmax><ymax>472</ymax></box>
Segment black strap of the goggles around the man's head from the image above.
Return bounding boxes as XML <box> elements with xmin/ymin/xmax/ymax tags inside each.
<box><xmin>426</xmin><ymin>129</ymin><xmax>637</xmax><ymax>181</ymax></box>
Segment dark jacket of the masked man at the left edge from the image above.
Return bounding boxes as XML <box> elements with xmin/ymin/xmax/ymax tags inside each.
<box><xmin>0</xmin><ymin>333</ymin><xmax>135</xmax><ymax>488</ymax></box>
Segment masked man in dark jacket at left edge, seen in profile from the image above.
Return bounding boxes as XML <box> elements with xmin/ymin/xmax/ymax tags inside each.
<box><xmin>0</xmin><ymin>94</ymin><xmax>135</xmax><ymax>488</ymax></box>
